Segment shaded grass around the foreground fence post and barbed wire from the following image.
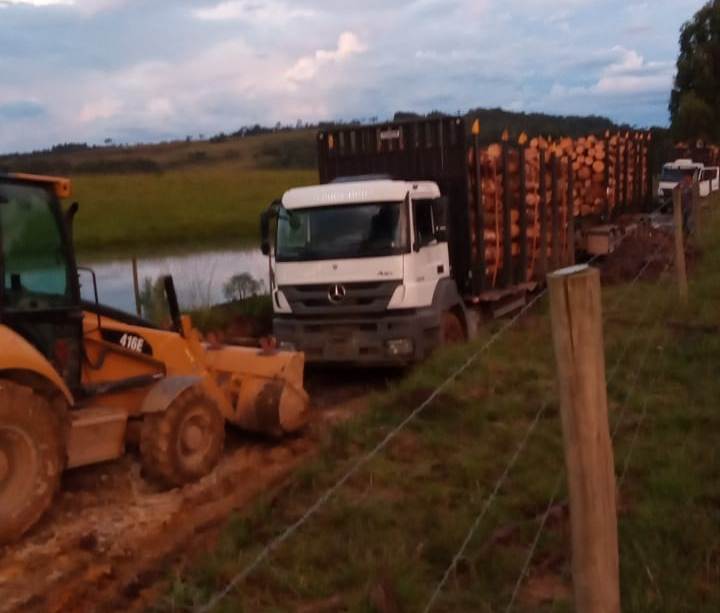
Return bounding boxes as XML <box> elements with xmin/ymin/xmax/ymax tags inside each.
<box><xmin>156</xmin><ymin>199</ymin><xmax>720</xmax><ymax>613</ymax></box>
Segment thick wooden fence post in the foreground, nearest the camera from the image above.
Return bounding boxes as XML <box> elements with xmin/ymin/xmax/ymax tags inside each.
<box><xmin>548</xmin><ymin>265</ymin><xmax>620</xmax><ymax>613</ymax></box>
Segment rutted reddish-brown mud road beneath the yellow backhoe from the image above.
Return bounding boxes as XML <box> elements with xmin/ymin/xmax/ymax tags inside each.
<box><xmin>0</xmin><ymin>370</ymin><xmax>392</xmax><ymax>613</ymax></box>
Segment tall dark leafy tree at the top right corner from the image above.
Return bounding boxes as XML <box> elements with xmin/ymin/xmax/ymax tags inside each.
<box><xmin>669</xmin><ymin>0</ymin><xmax>720</xmax><ymax>141</ymax></box>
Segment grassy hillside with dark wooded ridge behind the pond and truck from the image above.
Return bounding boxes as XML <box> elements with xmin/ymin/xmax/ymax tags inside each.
<box><xmin>0</xmin><ymin>109</ymin><xmax>668</xmax><ymax>258</ymax></box>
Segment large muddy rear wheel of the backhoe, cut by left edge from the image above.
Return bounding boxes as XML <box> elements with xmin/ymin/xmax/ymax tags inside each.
<box><xmin>0</xmin><ymin>379</ymin><xmax>65</xmax><ymax>544</ymax></box>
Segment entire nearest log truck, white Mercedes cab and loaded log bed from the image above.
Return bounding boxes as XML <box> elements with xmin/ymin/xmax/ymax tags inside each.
<box><xmin>261</xmin><ymin>117</ymin><xmax>652</xmax><ymax>365</ymax></box>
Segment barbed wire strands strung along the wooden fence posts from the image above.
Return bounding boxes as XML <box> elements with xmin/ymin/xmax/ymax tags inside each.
<box><xmin>195</xmin><ymin>203</ymin><xmax>688</xmax><ymax>613</ymax></box>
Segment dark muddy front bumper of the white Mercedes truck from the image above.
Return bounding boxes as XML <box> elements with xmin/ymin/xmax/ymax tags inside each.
<box><xmin>273</xmin><ymin>308</ymin><xmax>442</xmax><ymax>366</ymax></box>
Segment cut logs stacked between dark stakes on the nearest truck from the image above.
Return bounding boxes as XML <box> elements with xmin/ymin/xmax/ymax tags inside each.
<box><xmin>468</xmin><ymin>128</ymin><xmax>649</xmax><ymax>288</ymax></box>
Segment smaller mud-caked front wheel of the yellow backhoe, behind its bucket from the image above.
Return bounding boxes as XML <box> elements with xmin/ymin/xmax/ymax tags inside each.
<box><xmin>140</xmin><ymin>387</ymin><xmax>225</xmax><ymax>486</ymax></box>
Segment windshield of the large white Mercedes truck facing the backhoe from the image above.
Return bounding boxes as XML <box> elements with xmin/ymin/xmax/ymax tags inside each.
<box><xmin>275</xmin><ymin>202</ymin><xmax>409</xmax><ymax>262</ymax></box>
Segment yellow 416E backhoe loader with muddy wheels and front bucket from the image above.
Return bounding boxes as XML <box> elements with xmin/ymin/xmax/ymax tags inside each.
<box><xmin>0</xmin><ymin>174</ymin><xmax>308</xmax><ymax>543</ymax></box>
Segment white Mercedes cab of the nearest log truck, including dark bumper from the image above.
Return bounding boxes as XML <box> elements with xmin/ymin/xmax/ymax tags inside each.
<box><xmin>264</xmin><ymin>177</ymin><xmax>467</xmax><ymax>365</ymax></box>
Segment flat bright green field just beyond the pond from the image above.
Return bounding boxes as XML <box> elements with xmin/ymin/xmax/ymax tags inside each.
<box><xmin>73</xmin><ymin>162</ymin><xmax>317</xmax><ymax>257</ymax></box>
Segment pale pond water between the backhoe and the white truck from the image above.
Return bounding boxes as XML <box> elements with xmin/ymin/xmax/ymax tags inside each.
<box><xmin>78</xmin><ymin>249</ymin><xmax>269</xmax><ymax>313</ymax></box>
